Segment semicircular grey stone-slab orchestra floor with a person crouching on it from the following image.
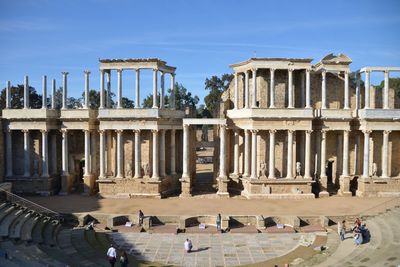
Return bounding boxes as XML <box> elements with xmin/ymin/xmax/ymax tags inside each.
<box><xmin>110</xmin><ymin>233</ymin><xmax>316</xmax><ymax>266</ymax></box>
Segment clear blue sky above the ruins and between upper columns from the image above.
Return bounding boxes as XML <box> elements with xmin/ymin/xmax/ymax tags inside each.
<box><xmin>0</xmin><ymin>0</ymin><xmax>400</xmax><ymax>104</ymax></box>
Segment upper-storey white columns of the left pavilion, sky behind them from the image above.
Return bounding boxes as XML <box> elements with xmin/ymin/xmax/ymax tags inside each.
<box><xmin>100</xmin><ymin>69</ymin><xmax>175</xmax><ymax>109</ymax></box>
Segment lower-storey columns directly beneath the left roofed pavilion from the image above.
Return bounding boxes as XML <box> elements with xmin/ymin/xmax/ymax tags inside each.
<box><xmin>99</xmin><ymin>129</ymin><xmax>176</xmax><ymax>180</ymax></box>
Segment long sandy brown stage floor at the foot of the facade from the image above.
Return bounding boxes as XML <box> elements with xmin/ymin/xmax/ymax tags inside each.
<box><xmin>28</xmin><ymin>194</ymin><xmax>400</xmax><ymax>216</ymax></box>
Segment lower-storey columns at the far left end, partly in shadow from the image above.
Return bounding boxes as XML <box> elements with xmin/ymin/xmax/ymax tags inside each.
<box><xmin>6</xmin><ymin>130</ymin><xmax>57</xmax><ymax>178</ymax></box>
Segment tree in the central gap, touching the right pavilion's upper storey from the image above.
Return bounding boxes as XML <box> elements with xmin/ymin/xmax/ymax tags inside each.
<box><xmin>204</xmin><ymin>74</ymin><xmax>233</xmax><ymax>116</ymax></box>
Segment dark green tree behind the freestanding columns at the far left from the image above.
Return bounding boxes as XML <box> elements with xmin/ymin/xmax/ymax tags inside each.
<box><xmin>0</xmin><ymin>84</ymin><xmax>42</xmax><ymax>109</ymax></box>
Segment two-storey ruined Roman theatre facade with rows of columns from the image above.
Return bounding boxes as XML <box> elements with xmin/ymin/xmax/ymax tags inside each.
<box><xmin>0</xmin><ymin>54</ymin><xmax>400</xmax><ymax>198</ymax></box>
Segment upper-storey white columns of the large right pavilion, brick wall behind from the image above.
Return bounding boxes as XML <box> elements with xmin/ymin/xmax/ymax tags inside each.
<box><xmin>234</xmin><ymin>69</ymin><xmax>352</xmax><ymax>109</ymax></box>
